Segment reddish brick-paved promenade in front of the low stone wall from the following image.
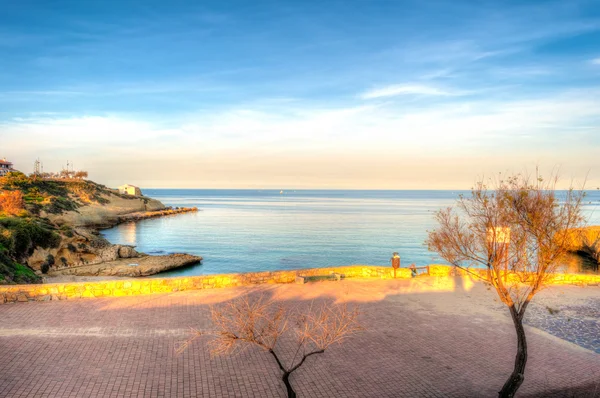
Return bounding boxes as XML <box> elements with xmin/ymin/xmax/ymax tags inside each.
<box><xmin>0</xmin><ymin>280</ymin><xmax>600</xmax><ymax>398</ymax></box>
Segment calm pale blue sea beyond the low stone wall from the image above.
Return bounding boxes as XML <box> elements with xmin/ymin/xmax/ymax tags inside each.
<box><xmin>102</xmin><ymin>189</ymin><xmax>600</xmax><ymax>276</ymax></box>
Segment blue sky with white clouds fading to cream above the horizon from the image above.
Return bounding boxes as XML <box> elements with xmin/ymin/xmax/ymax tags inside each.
<box><xmin>0</xmin><ymin>0</ymin><xmax>600</xmax><ymax>189</ymax></box>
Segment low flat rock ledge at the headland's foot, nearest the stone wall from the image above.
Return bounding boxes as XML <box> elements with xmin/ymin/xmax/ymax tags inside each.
<box><xmin>48</xmin><ymin>253</ymin><xmax>202</xmax><ymax>276</ymax></box>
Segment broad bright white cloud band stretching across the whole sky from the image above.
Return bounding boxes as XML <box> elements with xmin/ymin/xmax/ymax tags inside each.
<box><xmin>5</xmin><ymin>90</ymin><xmax>600</xmax><ymax>158</ymax></box>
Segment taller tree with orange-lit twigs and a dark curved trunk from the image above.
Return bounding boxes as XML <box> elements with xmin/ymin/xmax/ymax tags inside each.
<box><xmin>426</xmin><ymin>175</ymin><xmax>584</xmax><ymax>397</ymax></box>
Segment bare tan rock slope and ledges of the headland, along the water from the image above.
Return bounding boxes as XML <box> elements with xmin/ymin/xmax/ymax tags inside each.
<box><xmin>27</xmin><ymin>195</ymin><xmax>202</xmax><ymax>282</ymax></box>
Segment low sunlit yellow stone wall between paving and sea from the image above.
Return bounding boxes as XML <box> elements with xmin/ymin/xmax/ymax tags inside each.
<box><xmin>0</xmin><ymin>265</ymin><xmax>600</xmax><ymax>304</ymax></box>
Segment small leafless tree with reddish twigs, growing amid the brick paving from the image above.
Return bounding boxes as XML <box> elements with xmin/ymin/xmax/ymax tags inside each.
<box><xmin>177</xmin><ymin>295</ymin><xmax>362</xmax><ymax>398</ymax></box>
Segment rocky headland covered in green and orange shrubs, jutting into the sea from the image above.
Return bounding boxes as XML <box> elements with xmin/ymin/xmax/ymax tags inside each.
<box><xmin>0</xmin><ymin>173</ymin><xmax>201</xmax><ymax>283</ymax></box>
